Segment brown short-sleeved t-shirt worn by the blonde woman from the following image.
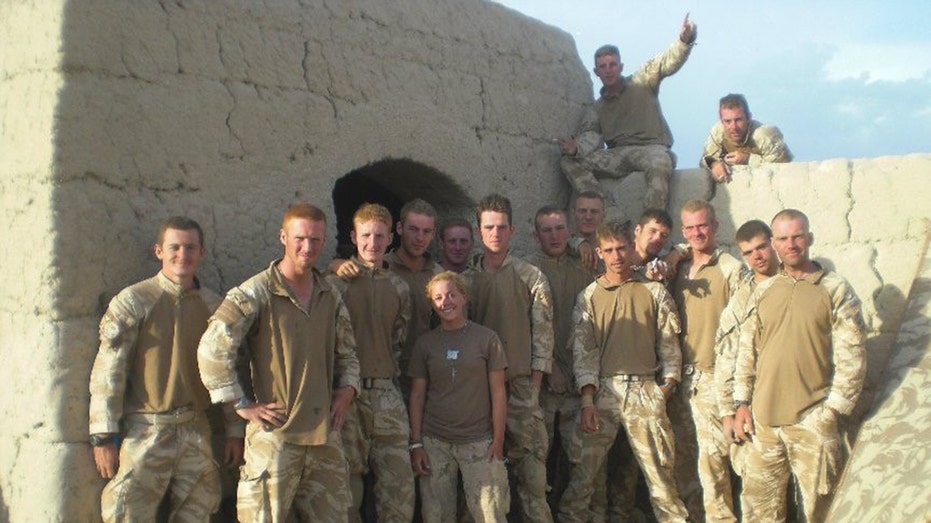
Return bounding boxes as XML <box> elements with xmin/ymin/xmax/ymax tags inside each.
<box><xmin>408</xmin><ymin>321</ymin><xmax>507</xmax><ymax>444</ymax></box>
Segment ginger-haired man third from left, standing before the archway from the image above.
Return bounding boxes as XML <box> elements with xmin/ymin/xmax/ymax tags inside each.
<box><xmin>327</xmin><ymin>203</ymin><xmax>414</xmax><ymax>523</ymax></box>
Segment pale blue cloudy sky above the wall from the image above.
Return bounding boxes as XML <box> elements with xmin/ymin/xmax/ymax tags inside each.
<box><xmin>496</xmin><ymin>0</ymin><xmax>931</xmax><ymax>164</ymax></box>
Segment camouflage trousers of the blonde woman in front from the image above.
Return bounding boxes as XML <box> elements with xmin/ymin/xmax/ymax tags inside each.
<box><xmin>420</xmin><ymin>436</ymin><xmax>511</xmax><ymax>523</ymax></box>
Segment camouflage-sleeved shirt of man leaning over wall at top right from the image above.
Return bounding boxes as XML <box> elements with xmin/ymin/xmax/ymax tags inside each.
<box><xmin>698</xmin><ymin>120</ymin><xmax>792</xmax><ymax>170</ymax></box>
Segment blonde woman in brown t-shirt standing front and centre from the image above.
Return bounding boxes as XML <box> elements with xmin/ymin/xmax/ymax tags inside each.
<box><xmin>410</xmin><ymin>271</ymin><xmax>510</xmax><ymax>523</ymax></box>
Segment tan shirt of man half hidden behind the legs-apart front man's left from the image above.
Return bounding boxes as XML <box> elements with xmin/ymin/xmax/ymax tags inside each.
<box><xmin>530</xmin><ymin>251</ymin><xmax>595</xmax><ymax>388</ymax></box>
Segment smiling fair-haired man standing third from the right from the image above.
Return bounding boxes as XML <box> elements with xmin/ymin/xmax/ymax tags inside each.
<box><xmin>669</xmin><ymin>200</ymin><xmax>742</xmax><ymax>521</ymax></box>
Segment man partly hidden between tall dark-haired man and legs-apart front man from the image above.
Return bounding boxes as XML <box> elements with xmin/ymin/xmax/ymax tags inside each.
<box><xmin>529</xmin><ymin>205</ymin><xmax>595</xmax><ymax>506</ymax></box>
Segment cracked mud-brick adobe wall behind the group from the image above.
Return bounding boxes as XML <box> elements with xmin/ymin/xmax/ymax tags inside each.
<box><xmin>0</xmin><ymin>0</ymin><xmax>931</xmax><ymax>522</ymax></box>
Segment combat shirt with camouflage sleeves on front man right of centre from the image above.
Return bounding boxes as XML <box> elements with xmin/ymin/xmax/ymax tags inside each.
<box><xmin>572</xmin><ymin>272</ymin><xmax>682</xmax><ymax>392</ymax></box>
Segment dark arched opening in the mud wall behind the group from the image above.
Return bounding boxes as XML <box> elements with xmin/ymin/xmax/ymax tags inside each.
<box><xmin>333</xmin><ymin>158</ymin><xmax>475</xmax><ymax>258</ymax></box>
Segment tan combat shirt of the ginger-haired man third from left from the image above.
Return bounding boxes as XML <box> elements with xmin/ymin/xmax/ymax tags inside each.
<box><xmin>327</xmin><ymin>256</ymin><xmax>411</xmax><ymax>379</ymax></box>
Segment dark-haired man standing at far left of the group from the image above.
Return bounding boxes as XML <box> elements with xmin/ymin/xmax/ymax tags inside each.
<box><xmin>89</xmin><ymin>216</ymin><xmax>244</xmax><ymax>521</ymax></box>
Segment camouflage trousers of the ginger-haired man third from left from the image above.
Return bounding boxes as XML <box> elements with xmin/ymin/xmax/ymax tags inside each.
<box><xmin>341</xmin><ymin>379</ymin><xmax>414</xmax><ymax>523</ymax></box>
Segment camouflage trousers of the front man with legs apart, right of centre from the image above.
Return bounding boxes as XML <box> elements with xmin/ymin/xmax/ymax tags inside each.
<box><xmin>559</xmin><ymin>376</ymin><xmax>688</xmax><ymax>523</ymax></box>
